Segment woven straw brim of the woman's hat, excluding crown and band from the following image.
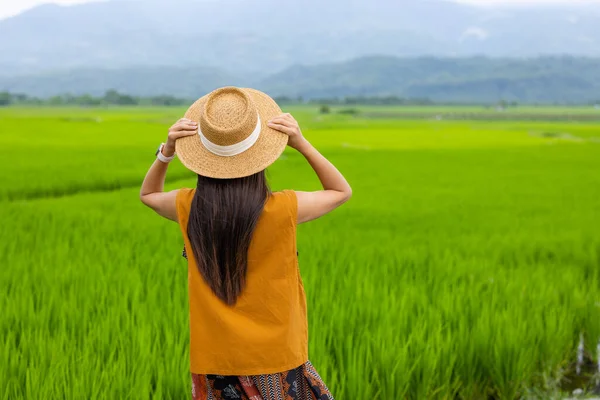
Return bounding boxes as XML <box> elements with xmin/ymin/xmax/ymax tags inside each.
<box><xmin>175</xmin><ymin>88</ymin><xmax>288</xmax><ymax>179</ymax></box>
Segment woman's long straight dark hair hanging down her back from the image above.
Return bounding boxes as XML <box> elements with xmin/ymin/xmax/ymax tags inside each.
<box><xmin>187</xmin><ymin>171</ymin><xmax>270</xmax><ymax>305</ymax></box>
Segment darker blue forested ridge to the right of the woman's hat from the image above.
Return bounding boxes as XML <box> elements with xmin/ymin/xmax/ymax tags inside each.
<box><xmin>256</xmin><ymin>57</ymin><xmax>600</xmax><ymax>103</ymax></box>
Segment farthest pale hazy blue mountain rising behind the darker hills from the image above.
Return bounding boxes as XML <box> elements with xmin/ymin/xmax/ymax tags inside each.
<box><xmin>0</xmin><ymin>0</ymin><xmax>600</xmax><ymax>78</ymax></box>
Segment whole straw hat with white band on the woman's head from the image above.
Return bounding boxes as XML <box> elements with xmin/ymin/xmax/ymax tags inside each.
<box><xmin>175</xmin><ymin>87</ymin><xmax>288</xmax><ymax>179</ymax></box>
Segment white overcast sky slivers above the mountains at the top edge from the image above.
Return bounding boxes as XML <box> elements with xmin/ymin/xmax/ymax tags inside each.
<box><xmin>0</xmin><ymin>0</ymin><xmax>600</xmax><ymax>19</ymax></box>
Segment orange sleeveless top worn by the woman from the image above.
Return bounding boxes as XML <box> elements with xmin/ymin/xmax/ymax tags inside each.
<box><xmin>176</xmin><ymin>188</ymin><xmax>308</xmax><ymax>375</ymax></box>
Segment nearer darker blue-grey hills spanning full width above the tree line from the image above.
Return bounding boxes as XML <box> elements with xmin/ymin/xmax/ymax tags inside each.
<box><xmin>0</xmin><ymin>56</ymin><xmax>600</xmax><ymax>103</ymax></box>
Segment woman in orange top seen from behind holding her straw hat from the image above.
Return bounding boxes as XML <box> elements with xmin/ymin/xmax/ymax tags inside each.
<box><xmin>140</xmin><ymin>87</ymin><xmax>352</xmax><ymax>400</ymax></box>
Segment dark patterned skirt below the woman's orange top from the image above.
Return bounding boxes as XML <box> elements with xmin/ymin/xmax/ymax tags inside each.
<box><xmin>192</xmin><ymin>361</ymin><xmax>333</xmax><ymax>400</ymax></box>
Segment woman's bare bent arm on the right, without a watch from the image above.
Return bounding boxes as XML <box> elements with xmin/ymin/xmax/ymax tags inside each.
<box><xmin>268</xmin><ymin>114</ymin><xmax>352</xmax><ymax>224</ymax></box>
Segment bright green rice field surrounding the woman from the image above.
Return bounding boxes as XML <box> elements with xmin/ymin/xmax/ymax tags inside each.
<box><xmin>0</xmin><ymin>105</ymin><xmax>600</xmax><ymax>400</ymax></box>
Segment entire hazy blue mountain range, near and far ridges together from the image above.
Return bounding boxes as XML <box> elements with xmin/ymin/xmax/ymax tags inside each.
<box><xmin>0</xmin><ymin>0</ymin><xmax>600</xmax><ymax>103</ymax></box>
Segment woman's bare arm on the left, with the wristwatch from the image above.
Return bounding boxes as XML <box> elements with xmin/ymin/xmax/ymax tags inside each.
<box><xmin>140</xmin><ymin>118</ymin><xmax>198</xmax><ymax>221</ymax></box>
